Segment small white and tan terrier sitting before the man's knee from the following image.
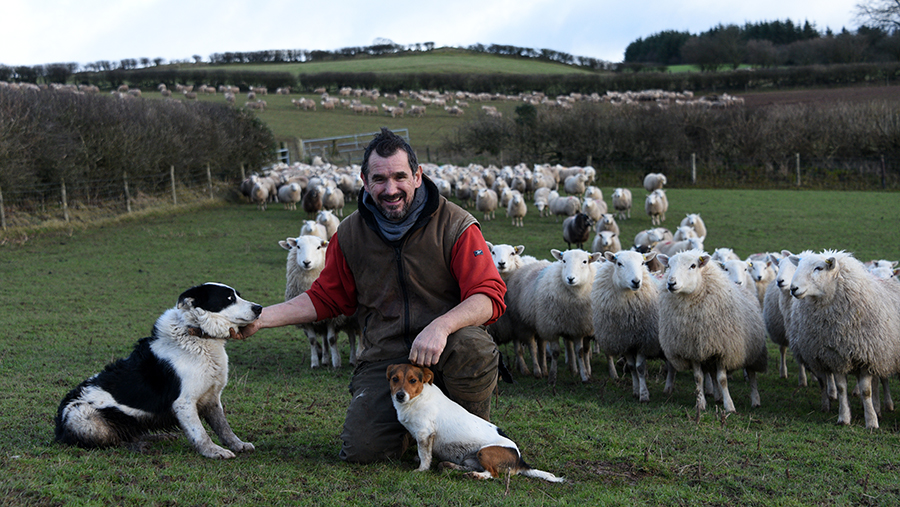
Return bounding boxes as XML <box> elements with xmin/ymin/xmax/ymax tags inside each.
<box><xmin>387</xmin><ymin>364</ymin><xmax>564</xmax><ymax>482</ymax></box>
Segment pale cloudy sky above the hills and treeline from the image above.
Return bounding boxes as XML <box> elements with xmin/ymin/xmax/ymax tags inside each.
<box><xmin>0</xmin><ymin>0</ymin><xmax>859</xmax><ymax>66</ymax></box>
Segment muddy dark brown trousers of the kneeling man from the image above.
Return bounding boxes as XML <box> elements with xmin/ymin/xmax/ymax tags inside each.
<box><xmin>340</xmin><ymin>327</ymin><xmax>500</xmax><ymax>463</ymax></box>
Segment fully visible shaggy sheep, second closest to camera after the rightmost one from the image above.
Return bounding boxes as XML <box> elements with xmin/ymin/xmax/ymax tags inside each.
<box><xmin>657</xmin><ymin>249</ymin><xmax>768</xmax><ymax>412</ymax></box>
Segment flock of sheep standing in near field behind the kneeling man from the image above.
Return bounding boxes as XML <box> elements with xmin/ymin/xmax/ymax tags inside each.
<box><xmin>243</xmin><ymin>159</ymin><xmax>900</xmax><ymax>428</ymax></box>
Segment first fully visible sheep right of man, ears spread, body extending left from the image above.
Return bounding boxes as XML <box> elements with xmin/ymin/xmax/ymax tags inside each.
<box><xmin>506</xmin><ymin>249</ymin><xmax>600</xmax><ymax>384</ymax></box>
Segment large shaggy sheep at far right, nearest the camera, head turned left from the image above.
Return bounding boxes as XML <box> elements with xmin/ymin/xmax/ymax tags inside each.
<box><xmin>787</xmin><ymin>250</ymin><xmax>900</xmax><ymax>429</ymax></box>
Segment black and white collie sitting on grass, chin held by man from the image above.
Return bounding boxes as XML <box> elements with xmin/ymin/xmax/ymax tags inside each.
<box><xmin>56</xmin><ymin>283</ymin><xmax>262</xmax><ymax>458</ymax></box>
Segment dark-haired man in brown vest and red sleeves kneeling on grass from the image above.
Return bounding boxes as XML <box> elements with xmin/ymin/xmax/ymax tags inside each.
<box><xmin>234</xmin><ymin>128</ymin><xmax>506</xmax><ymax>463</ymax></box>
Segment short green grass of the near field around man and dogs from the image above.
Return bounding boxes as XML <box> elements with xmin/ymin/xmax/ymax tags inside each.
<box><xmin>0</xmin><ymin>189</ymin><xmax>900</xmax><ymax>506</ymax></box>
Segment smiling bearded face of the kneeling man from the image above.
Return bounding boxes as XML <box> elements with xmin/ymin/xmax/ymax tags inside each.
<box><xmin>363</xmin><ymin>150</ymin><xmax>422</xmax><ymax>220</ymax></box>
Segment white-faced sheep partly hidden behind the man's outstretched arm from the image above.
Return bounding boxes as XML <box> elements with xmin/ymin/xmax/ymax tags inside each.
<box><xmin>278</xmin><ymin>235</ymin><xmax>358</xmax><ymax>368</ymax></box>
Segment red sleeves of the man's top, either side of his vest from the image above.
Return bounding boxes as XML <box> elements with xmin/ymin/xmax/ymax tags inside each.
<box><xmin>307</xmin><ymin>226</ymin><xmax>506</xmax><ymax>324</ymax></box>
